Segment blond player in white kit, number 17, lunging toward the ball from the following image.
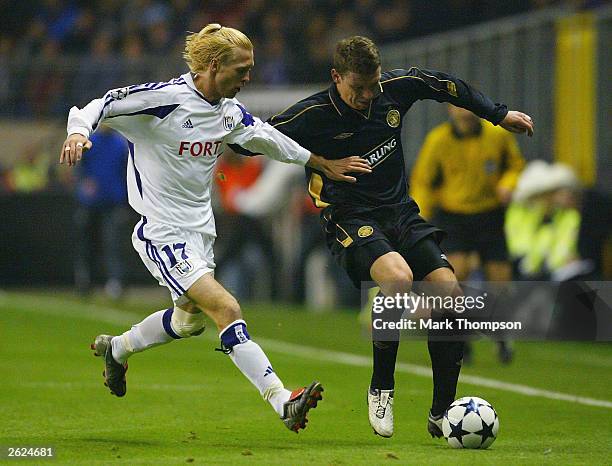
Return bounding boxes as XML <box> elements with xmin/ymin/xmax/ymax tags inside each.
<box><xmin>60</xmin><ymin>24</ymin><xmax>370</xmax><ymax>432</ymax></box>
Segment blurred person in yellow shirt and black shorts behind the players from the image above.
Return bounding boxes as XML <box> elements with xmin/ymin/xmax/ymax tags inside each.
<box><xmin>410</xmin><ymin>105</ymin><xmax>525</xmax><ymax>362</ymax></box>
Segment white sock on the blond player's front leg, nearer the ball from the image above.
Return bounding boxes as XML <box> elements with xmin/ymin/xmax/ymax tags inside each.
<box><xmin>229</xmin><ymin>340</ymin><xmax>291</xmax><ymax>417</ymax></box>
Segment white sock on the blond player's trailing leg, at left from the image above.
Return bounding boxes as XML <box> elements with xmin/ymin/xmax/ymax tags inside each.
<box><xmin>111</xmin><ymin>309</ymin><xmax>178</xmax><ymax>364</ymax></box>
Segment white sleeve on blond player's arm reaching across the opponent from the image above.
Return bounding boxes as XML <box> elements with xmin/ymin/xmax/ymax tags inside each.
<box><xmin>226</xmin><ymin>104</ymin><xmax>310</xmax><ymax>166</ymax></box>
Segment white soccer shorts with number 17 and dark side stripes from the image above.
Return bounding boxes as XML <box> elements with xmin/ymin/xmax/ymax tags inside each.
<box><xmin>132</xmin><ymin>217</ymin><xmax>215</xmax><ymax>303</ymax></box>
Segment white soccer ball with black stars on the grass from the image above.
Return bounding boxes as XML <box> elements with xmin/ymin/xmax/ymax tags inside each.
<box><xmin>442</xmin><ymin>396</ymin><xmax>499</xmax><ymax>449</ymax></box>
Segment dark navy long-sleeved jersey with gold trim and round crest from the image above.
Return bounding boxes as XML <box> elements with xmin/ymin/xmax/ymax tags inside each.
<box><xmin>268</xmin><ymin>68</ymin><xmax>508</xmax><ymax>212</ymax></box>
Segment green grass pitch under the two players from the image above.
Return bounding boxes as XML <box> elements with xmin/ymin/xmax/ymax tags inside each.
<box><xmin>0</xmin><ymin>292</ymin><xmax>612</xmax><ymax>465</ymax></box>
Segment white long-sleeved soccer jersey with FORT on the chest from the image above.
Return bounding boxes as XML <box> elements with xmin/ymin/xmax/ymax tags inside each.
<box><xmin>68</xmin><ymin>73</ymin><xmax>310</xmax><ymax>236</ymax></box>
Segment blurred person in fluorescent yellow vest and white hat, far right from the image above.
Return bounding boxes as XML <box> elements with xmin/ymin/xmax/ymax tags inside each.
<box><xmin>506</xmin><ymin>160</ymin><xmax>592</xmax><ymax>341</ymax></box>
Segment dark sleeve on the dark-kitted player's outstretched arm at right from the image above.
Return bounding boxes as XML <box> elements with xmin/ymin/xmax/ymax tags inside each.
<box><xmin>382</xmin><ymin>67</ymin><xmax>508</xmax><ymax>125</ymax></box>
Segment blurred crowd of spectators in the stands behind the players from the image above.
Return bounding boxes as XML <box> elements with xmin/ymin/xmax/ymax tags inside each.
<box><xmin>0</xmin><ymin>0</ymin><xmax>604</xmax><ymax>118</ymax></box>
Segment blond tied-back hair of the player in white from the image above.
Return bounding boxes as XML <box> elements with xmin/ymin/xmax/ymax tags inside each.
<box><xmin>183</xmin><ymin>23</ymin><xmax>253</xmax><ymax>73</ymax></box>
